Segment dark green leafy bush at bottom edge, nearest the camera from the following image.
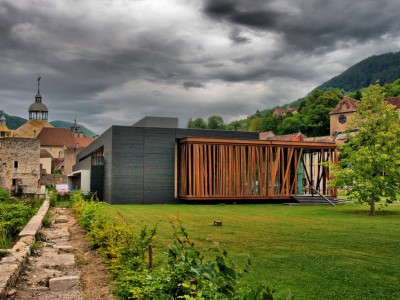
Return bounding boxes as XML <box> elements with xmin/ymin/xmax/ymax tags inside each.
<box><xmin>116</xmin><ymin>220</ymin><xmax>253</xmax><ymax>299</ymax></box>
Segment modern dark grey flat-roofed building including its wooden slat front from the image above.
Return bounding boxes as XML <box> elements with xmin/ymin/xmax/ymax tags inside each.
<box><xmin>68</xmin><ymin>117</ymin><xmax>337</xmax><ymax>204</ymax></box>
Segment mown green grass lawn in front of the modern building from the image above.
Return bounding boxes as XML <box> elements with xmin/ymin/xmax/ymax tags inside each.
<box><xmin>107</xmin><ymin>204</ymin><xmax>400</xmax><ymax>300</ymax></box>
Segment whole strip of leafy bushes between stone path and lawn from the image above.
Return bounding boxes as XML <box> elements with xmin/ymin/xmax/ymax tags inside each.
<box><xmin>72</xmin><ymin>191</ymin><xmax>274</xmax><ymax>300</ymax></box>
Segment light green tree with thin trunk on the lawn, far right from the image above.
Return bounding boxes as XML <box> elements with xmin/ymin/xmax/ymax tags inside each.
<box><xmin>331</xmin><ymin>84</ymin><xmax>400</xmax><ymax>215</ymax></box>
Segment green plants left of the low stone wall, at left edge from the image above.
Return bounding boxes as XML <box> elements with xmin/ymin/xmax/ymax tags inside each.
<box><xmin>0</xmin><ymin>188</ymin><xmax>41</xmax><ymax>248</ymax></box>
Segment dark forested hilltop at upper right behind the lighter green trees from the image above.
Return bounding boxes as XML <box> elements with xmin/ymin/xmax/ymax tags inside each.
<box><xmin>316</xmin><ymin>52</ymin><xmax>400</xmax><ymax>92</ymax></box>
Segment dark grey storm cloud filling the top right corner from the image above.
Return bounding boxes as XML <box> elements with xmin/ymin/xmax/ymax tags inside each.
<box><xmin>204</xmin><ymin>0</ymin><xmax>400</xmax><ymax>52</ymax></box>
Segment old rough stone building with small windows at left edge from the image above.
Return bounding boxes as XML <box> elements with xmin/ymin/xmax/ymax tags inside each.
<box><xmin>0</xmin><ymin>137</ymin><xmax>40</xmax><ymax>193</ymax></box>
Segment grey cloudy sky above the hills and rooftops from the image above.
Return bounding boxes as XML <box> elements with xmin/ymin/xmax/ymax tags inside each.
<box><xmin>0</xmin><ymin>0</ymin><xmax>400</xmax><ymax>133</ymax></box>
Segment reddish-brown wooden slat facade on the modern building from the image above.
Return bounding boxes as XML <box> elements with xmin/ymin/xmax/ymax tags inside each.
<box><xmin>178</xmin><ymin>138</ymin><xmax>337</xmax><ymax>200</ymax></box>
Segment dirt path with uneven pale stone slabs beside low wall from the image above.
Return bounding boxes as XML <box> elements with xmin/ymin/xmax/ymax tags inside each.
<box><xmin>10</xmin><ymin>208</ymin><xmax>114</xmax><ymax>300</ymax></box>
